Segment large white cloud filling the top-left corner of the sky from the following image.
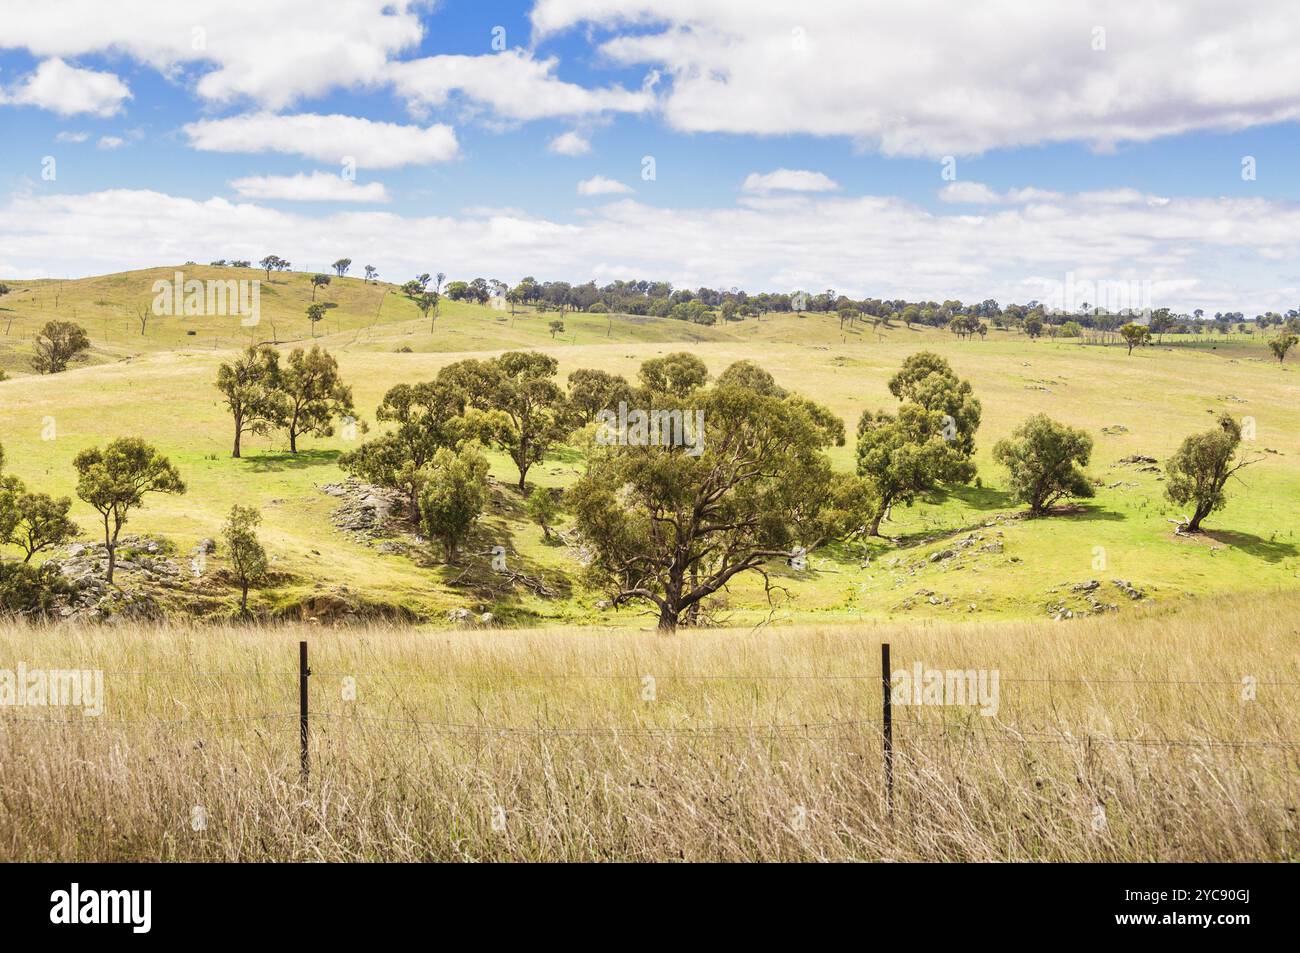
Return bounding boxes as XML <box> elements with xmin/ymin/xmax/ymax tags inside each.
<box><xmin>0</xmin><ymin>0</ymin><xmax>424</xmax><ymax>109</ymax></box>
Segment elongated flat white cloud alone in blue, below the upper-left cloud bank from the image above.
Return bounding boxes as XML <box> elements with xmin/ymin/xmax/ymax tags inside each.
<box><xmin>185</xmin><ymin>113</ymin><xmax>459</xmax><ymax>169</ymax></box>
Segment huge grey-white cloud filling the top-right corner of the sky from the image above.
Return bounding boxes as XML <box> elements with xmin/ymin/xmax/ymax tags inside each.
<box><xmin>532</xmin><ymin>0</ymin><xmax>1300</xmax><ymax>157</ymax></box>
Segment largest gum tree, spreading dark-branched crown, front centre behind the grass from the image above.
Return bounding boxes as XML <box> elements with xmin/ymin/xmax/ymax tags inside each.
<box><xmin>566</xmin><ymin>374</ymin><xmax>871</xmax><ymax>632</ymax></box>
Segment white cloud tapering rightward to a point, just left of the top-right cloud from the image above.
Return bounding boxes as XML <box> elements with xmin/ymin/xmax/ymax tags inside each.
<box><xmin>389</xmin><ymin>49</ymin><xmax>654</xmax><ymax>121</ymax></box>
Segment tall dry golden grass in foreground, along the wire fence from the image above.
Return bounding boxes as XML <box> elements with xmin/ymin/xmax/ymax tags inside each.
<box><xmin>0</xmin><ymin>594</ymin><xmax>1300</xmax><ymax>861</ymax></box>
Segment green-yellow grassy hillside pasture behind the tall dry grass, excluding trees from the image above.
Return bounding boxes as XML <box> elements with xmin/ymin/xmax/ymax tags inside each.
<box><xmin>0</xmin><ymin>267</ymin><xmax>1300</xmax><ymax>625</ymax></box>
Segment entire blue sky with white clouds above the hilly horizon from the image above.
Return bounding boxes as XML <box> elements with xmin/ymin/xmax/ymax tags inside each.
<box><xmin>0</xmin><ymin>0</ymin><xmax>1300</xmax><ymax>313</ymax></box>
